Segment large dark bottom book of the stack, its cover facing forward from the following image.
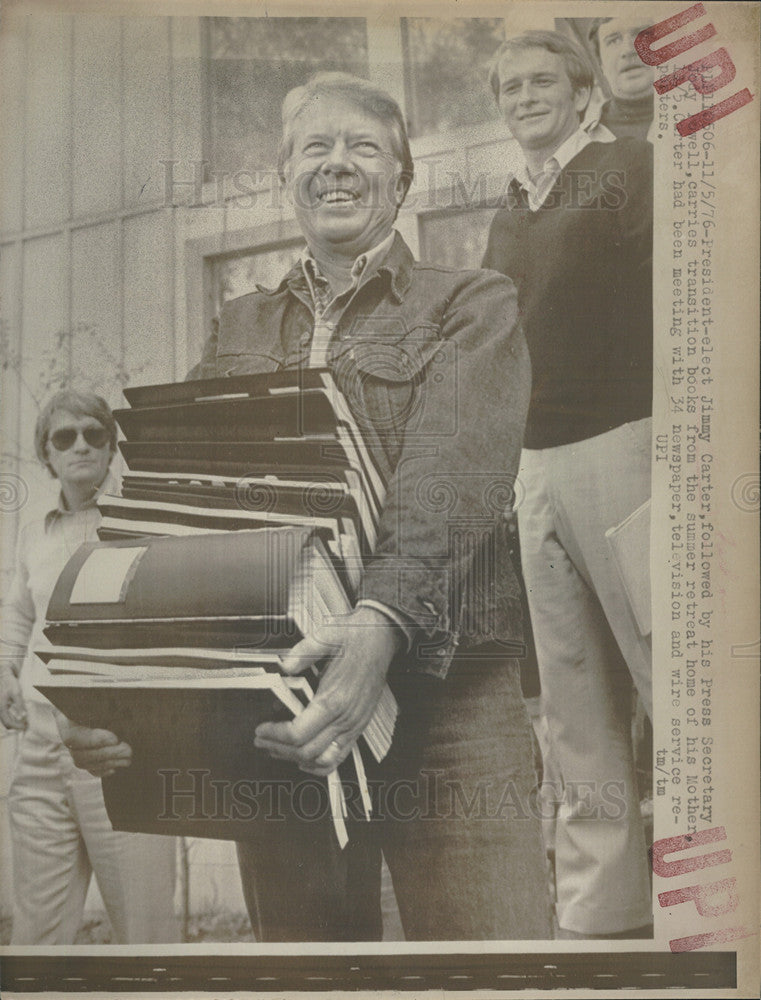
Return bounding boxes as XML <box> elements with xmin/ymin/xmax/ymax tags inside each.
<box><xmin>39</xmin><ymin>667</ymin><xmax>336</xmax><ymax>840</ymax></box>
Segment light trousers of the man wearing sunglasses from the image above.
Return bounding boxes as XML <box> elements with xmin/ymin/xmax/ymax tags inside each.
<box><xmin>9</xmin><ymin>700</ymin><xmax>179</xmax><ymax>945</ymax></box>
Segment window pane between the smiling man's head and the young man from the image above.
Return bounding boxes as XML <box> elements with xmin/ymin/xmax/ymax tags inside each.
<box><xmin>402</xmin><ymin>17</ymin><xmax>504</xmax><ymax>136</ymax></box>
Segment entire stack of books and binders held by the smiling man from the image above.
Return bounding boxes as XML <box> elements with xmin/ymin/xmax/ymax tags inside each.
<box><xmin>37</xmin><ymin>370</ymin><xmax>396</xmax><ymax>843</ymax></box>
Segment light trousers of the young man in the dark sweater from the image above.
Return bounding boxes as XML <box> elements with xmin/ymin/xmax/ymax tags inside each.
<box><xmin>518</xmin><ymin>419</ymin><xmax>652</xmax><ymax>934</ymax></box>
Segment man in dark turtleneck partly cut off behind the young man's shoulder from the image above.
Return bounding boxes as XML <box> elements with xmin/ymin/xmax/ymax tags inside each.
<box><xmin>589</xmin><ymin>11</ymin><xmax>655</xmax><ymax>139</ymax></box>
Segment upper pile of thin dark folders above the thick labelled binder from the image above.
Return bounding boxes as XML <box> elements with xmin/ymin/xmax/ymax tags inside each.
<box><xmin>99</xmin><ymin>369</ymin><xmax>385</xmax><ymax>596</ymax></box>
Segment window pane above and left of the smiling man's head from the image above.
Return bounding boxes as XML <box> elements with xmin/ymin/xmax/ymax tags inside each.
<box><xmin>202</xmin><ymin>17</ymin><xmax>368</xmax><ymax>173</ymax></box>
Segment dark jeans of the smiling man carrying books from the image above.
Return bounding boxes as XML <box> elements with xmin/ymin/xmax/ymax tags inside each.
<box><xmin>238</xmin><ymin>654</ymin><xmax>550</xmax><ymax>941</ymax></box>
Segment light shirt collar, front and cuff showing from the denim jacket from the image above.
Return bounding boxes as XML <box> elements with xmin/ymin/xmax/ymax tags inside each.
<box><xmin>301</xmin><ymin>230</ymin><xmax>412</xmax><ymax>650</ymax></box>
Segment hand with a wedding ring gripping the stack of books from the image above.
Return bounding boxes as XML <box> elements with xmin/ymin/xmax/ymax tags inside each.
<box><xmin>255</xmin><ymin>607</ymin><xmax>402</xmax><ymax>775</ymax></box>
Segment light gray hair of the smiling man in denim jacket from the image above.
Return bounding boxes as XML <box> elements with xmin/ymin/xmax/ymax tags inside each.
<box><xmin>277</xmin><ymin>73</ymin><xmax>415</xmax><ymax>194</ymax></box>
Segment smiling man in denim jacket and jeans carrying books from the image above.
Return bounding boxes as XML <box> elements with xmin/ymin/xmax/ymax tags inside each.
<box><xmin>56</xmin><ymin>73</ymin><xmax>550</xmax><ymax>941</ymax></box>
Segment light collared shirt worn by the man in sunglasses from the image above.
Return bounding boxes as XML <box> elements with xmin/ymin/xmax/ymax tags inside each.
<box><xmin>0</xmin><ymin>472</ymin><xmax>117</xmax><ymax>704</ymax></box>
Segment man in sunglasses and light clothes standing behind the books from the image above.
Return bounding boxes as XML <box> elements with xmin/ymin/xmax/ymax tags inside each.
<box><xmin>0</xmin><ymin>391</ymin><xmax>178</xmax><ymax>945</ymax></box>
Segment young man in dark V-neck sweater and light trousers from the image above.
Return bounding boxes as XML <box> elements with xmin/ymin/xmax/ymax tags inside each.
<box><xmin>483</xmin><ymin>31</ymin><xmax>653</xmax><ymax>937</ymax></box>
